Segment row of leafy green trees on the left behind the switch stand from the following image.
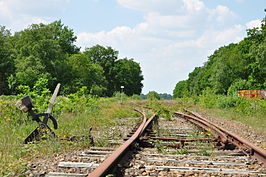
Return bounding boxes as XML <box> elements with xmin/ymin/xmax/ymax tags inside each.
<box><xmin>0</xmin><ymin>21</ymin><xmax>143</xmax><ymax>96</ymax></box>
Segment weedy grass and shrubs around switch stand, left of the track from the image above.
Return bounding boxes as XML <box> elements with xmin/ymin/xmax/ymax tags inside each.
<box><xmin>0</xmin><ymin>78</ymin><xmax>139</xmax><ymax>176</ymax></box>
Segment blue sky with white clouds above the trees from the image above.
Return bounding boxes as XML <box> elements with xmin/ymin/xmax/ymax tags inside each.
<box><xmin>0</xmin><ymin>0</ymin><xmax>266</xmax><ymax>93</ymax></box>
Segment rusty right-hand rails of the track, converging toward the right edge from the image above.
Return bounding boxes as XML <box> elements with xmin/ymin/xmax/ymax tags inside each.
<box><xmin>175</xmin><ymin>111</ymin><xmax>266</xmax><ymax>166</ymax></box>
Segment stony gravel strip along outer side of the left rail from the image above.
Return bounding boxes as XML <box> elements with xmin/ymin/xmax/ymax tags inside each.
<box><xmin>21</xmin><ymin>118</ymin><xmax>137</xmax><ymax>176</ymax></box>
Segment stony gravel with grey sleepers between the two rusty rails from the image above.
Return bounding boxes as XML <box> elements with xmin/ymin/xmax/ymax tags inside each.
<box><xmin>124</xmin><ymin>118</ymin><xmax>266</xmax><ymax>177</ymax></box>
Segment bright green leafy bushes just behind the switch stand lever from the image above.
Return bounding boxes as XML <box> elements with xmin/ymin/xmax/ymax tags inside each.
<box><xmin>16</xmin><ymin>78</ymin><xmax>97</xmax><ymax>116</ymax></box>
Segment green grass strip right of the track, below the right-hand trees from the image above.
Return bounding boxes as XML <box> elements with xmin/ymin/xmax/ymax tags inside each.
<box><xmin>194</xmin><ymin>90</ymin><xmax>266</xmax><ymax>133</ymax></box>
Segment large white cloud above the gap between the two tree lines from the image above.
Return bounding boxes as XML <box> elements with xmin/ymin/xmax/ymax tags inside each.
<box><xmin>77</xmin><ymin>0</ymin><xmax>244</xmax><ymax>93</ymax></box>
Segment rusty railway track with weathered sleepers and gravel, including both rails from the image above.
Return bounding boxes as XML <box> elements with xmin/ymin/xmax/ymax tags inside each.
<box><xmin>46</xmin><ymin>108</ymin><xmax>266</xmax><ymax>177</ymax></box>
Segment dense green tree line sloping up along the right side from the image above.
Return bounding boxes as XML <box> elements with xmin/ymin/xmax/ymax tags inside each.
<box><xmin>173</xmin><ymin>10</ymin><xmax>266</xmax><ymax>98</ymax></box>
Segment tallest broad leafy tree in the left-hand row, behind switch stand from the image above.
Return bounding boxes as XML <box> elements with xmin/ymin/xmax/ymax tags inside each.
<box><xmin>12</xmin><ymin>21</ymin><xmax>79</xmax><ymax>90</ymax></box>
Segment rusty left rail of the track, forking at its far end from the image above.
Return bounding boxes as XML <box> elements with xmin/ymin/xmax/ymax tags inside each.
<box><xmin>89</xmin><ymin>109</ymin><xmax>157</xmax><ymax>177</ymax></box>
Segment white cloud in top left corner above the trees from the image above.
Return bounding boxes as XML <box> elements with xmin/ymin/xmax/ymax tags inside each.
<box><xmin>0</xmin><ymin>0</ymin><xmax>70</xmax><ymax>31</ymax></box>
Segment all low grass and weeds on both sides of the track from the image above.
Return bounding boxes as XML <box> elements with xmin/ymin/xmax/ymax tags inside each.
<box><xmin>0</xmin><ymin>78</ymin><xmax>266</xmax><ymax>176</ymax></box>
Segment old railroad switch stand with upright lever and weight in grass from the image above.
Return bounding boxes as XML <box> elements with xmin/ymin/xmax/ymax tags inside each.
<box><xmin>16</xmin><ymin>84</ymin><xmax>60</xmax><ymax>144</ymax></box>
